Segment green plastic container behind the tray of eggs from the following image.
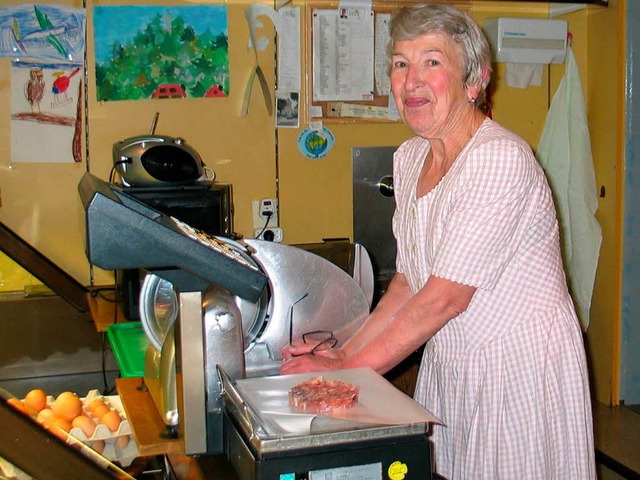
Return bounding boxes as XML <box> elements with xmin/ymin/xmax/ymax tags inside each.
<box><xmin>107</xmin><ymin>322</ymin><xmax>149</xmax><ymax>378</ymax></box>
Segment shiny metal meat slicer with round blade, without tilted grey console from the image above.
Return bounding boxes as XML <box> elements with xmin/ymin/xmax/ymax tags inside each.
<box><xmin>140</xmin><ymin>237</ymin><xmax>373</xmax><ymax>454</ymax></box>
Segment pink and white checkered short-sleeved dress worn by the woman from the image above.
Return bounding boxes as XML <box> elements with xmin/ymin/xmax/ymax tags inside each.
<box><xmin>393</xmin><ymin>119</ymin><xmax>596</xmax><ymax>480</ymax></box>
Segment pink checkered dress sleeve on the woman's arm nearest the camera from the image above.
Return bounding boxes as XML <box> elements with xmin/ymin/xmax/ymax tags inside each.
<box><xmin>431</xmin><ymin>137</ymin><xmax>547</xmax><ymax>289</ymax></box>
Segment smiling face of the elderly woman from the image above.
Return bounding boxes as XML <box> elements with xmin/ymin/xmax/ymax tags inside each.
<box><xmin>391</xmin><ymin>33</ymin><xmax>470</xmax><ymax>138</ymax></box>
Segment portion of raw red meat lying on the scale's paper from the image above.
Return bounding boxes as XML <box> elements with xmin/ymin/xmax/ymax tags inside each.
<box><xmin>289</xmin><ymin>376</ymin><xmax>360</xmax><ymax>413</ymax></box>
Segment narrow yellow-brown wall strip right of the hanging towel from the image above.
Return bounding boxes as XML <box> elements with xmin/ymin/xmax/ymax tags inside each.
<box><xmin>580</xmin><ymin>0</ymin><xmax>626</xmax><ymax>405</ymax></box>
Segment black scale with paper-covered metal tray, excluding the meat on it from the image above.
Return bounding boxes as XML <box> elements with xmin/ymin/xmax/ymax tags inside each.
<box><xmin>220</xmin><ymin>368</ymin><xmax>437</xmax><ymax>480</ymax></box>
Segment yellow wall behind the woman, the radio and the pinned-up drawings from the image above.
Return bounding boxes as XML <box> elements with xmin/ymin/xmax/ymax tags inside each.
<box><xmin>0</xmin><ymin>0</ymin><xmax>624</xmax><ymax>401</ymax></box>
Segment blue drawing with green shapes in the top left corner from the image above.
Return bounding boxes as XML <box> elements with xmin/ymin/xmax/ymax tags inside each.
<box><xmin>0</xmin><ymin>4</ymin><xmax>86</xmax><ymax>65</ymax></box>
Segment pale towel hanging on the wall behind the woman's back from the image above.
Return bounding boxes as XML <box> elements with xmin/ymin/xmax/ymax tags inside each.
<box><xmin>536</xmin><ymin>46</ymin><xmax>602</xmax><ymax>330</ymax></box>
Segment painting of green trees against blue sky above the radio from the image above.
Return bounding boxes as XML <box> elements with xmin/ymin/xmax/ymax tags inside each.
<box><xmin>93</xmin><ymin>5</ymin><xmax>229</xmax><ymax>101</ymax></box>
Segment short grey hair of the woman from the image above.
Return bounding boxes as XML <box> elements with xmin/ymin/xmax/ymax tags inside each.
<box><xmin>389</xmin><ymin>3</ymin><xmax>492</xmax><ymax>107</ymax></box>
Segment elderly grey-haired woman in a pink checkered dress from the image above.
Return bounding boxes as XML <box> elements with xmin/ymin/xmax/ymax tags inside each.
<box><xmin>281</xmin><ymin>4</ymin><xmax>595</xmax><ymax>480</ymax></box>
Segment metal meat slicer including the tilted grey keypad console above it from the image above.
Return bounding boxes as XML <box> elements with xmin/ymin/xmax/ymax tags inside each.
<box><xmin>79</xmin><ymin>173</ymin><xmax>373</xmax><ymax>454</ymax></box>
